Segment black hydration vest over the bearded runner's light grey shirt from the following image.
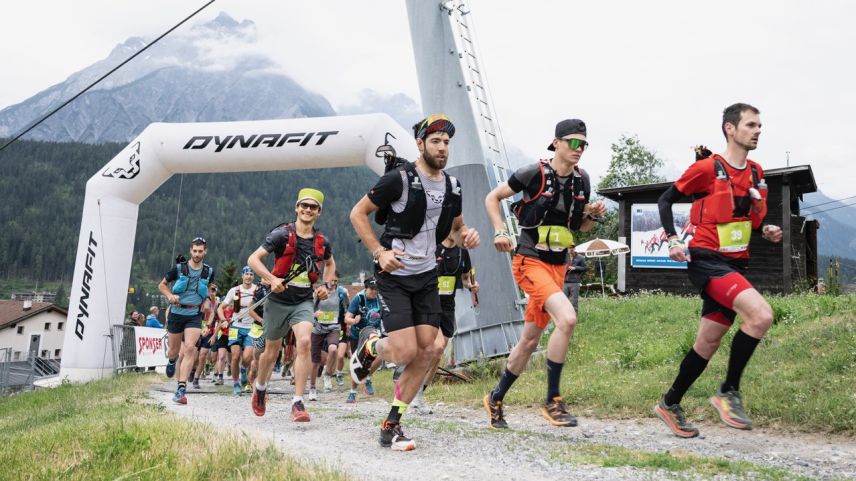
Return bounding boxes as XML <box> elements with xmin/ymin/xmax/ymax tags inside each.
<box><xmin>375</xmin><ymin>161</ymin><xmax>462</xmax><ymax>249</ymax></box>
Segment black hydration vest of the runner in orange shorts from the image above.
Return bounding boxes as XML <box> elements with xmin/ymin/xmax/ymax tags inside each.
<box><xmin>511</xmin><ymin>160</ymin><xmax>586</xmax><ymax>231</ymax></box>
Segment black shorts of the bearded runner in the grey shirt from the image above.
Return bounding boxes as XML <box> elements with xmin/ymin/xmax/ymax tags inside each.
<box><xmin>377</xmin><ymin>269</ymin><xmax>443</xmax><ymax>332</ymax></box>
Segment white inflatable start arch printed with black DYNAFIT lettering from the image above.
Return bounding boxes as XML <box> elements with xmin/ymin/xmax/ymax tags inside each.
<box><xmin>60</xmin><ymin>114</ymin><xmax>418</xmax><ymax>381</ymax></box>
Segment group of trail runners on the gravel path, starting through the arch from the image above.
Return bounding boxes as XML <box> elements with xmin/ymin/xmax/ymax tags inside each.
<box><xmin>160</xmin><ymin>103</ymin><xmax>782</xmax><ymax>451</ymax></box>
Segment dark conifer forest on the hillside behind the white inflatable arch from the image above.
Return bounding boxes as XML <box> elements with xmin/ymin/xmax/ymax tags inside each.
<box><xmin>0</xmin><ymin>137</ymin><xmax>377</xmax><ymax>284</ymax></box>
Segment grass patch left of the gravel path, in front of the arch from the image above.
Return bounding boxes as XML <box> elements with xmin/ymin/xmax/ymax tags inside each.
<box><xmin>0</xmin><ymin>374</ymin><xmax>348</xmax><ymax>481</ymax></box>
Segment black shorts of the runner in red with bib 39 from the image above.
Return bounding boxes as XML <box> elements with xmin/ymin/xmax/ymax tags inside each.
<box><xmin>687</xmin><ymin>249</ymin><xmax>748</xmax><ymax>325</ymax></box>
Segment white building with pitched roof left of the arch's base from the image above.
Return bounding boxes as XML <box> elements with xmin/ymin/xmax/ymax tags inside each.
<box><xmin>0</xmin><ymin>301</ymin><xmax>68</xmax><ymax>361</ymax></box>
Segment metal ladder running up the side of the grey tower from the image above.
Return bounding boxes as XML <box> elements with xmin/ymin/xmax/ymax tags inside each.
<box><xmin>440</xmin><ymin>0</ymin><xmax>520</xmax><ymax>241</ymax></box>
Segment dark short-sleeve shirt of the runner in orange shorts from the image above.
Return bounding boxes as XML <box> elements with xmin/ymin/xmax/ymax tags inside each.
<box><xmin>508</xmin><ymin>163</ymin><xmax>591</xmax><ymax>265</ymax></box>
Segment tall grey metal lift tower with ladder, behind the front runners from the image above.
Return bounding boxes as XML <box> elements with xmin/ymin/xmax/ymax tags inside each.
<box><xmin>407</xmin><ymin>0</ymin><xmax>523</xmax><ymax>363</ymax></box>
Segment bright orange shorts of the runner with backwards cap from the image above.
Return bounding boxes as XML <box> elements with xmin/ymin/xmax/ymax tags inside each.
<box><xmin>511</xmin><ymin>254</ymin><xmax>568</xmax><ymax>329</ymax></box>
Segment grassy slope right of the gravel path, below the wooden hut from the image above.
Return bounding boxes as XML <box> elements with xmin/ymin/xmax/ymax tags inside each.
<box><xmin>375</xmin><ymin>294</ymin><xmax>856</xmax><ymax>435</ymax></box>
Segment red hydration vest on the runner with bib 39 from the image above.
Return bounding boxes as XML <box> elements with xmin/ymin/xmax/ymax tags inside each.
<box><xmin>690</xmin><ymin>156</ymin><xmax>768</xmax><ymax>229</ymax></box>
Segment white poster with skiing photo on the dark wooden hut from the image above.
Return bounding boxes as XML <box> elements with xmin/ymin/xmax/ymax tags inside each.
<box><xmin>630</xmin><ymin>204</ymin><xmax>695</xmax><ymax>269</ymax></box>
